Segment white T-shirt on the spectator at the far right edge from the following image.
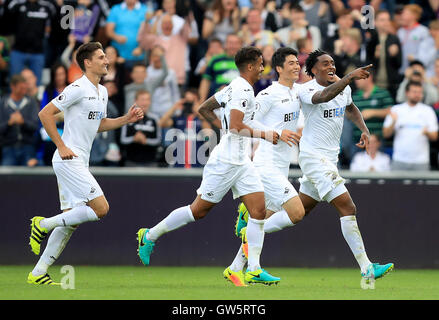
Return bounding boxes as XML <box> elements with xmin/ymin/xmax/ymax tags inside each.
<box><xmin>383</xmin><ymin>103</ymin><xmax>438</xmax><ymax>164</ymax></box>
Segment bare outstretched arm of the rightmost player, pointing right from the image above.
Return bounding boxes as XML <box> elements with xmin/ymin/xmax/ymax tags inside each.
<box><xmin>311</xmin><ymin>64</ymin><xmax>372</xmax><ymax>104</ymax></box>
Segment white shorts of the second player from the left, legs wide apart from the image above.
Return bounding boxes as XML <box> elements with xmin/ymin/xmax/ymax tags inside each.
<box><xmin>197</xmin><ymin>159</ymin><xmax>264</xmax><ymax>203</ymax></box>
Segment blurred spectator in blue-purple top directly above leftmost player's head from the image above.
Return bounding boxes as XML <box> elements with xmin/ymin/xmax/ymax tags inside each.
<box><xmin>71</xmin><ymin>0</ymin><xmax>100</xmax><ymax>44</ymax></box>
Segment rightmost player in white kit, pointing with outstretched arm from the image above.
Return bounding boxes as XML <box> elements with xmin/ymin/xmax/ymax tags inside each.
<box><xmin>299</xmin><ymin>50</ymin><xmax>394</xmax><ymax>283</ymax></box>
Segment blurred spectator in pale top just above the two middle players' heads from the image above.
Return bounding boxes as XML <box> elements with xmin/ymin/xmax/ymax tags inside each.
<box><xmin>238</xmin><ymin>9</ymin><xmax>280</xmax><ymax>49</ymax></box>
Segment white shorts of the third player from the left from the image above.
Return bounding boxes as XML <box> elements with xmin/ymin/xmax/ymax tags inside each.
<box><xmin>256</xmin><ymin>166</ymin><xmax>298</xmax><ymax>212</ymax></box>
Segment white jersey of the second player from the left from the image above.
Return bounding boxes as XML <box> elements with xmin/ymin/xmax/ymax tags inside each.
<box><xmin>209</xmin><ymin>77</ymin><xmax>256</xmax><ymax>165</ymax></box>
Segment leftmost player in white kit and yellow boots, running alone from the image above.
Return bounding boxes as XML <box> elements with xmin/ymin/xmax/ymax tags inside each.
<box><xmin>27</xmin><ymin>42</ymin><xmax>143</xmax><ymax>285</ymax></box>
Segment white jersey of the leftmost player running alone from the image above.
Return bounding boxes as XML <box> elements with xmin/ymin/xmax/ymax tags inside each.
<box><xmin>52</xmin><ymin>75</ymin><xmax>108</xmax><ymax>166</ymax></box>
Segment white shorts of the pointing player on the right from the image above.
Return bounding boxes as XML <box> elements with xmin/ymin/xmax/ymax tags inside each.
<box><xmin>299</xmin><ymin>152</ymin><xmax>347</xmax><ymax>203</ymax></box>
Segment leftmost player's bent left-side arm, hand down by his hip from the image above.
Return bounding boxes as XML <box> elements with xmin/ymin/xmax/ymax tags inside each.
<box><xmin>38</xmin><ymin>102</ymin><xmax>77</xmax><ymax>160</ymax></box>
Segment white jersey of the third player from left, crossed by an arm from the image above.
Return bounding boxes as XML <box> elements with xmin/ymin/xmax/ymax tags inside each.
<box><xmin>253</xmin><ymin>81</ymin><xmax>300</xmax><ymax>167</ymax></box>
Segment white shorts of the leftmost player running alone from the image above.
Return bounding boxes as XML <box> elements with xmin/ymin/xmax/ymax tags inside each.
<box><xmin>52</xmin><ymin>160</ymin><xmax>104</xmax><ymax>210</ymax></box>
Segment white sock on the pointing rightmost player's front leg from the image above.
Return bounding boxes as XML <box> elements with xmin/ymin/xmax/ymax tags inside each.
<box><xmin>340</xmin><ymin>216</ymin><xmax>371</xmax><ymax>272</ymax></box>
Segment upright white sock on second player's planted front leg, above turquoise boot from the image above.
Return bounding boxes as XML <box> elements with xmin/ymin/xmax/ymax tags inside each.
<box><xmin>247</xmin><ymin>217</ymin><xmax>265</xmax><ymax>271</ymax></box>
